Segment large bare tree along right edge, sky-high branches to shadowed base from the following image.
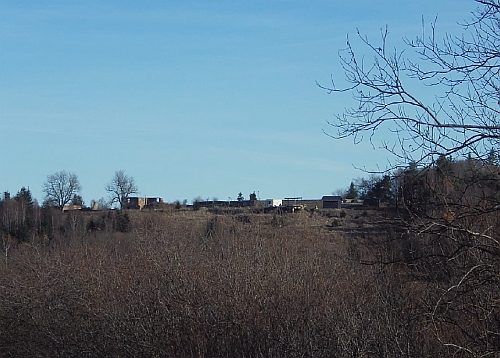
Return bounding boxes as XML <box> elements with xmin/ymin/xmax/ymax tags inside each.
<box><xmin>318</xmin><ymin>0</ymin><xmax>500</xmax><ymax>357</ymax></box>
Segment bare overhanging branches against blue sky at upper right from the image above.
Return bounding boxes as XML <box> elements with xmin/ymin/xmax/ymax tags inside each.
<box><xmin>318</xmin><ymin>1</ymin><xmax>500</xmax><ymax>169</ymax></box>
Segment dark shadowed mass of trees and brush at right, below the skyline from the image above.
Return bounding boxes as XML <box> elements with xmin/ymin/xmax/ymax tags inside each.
<box><xmin>346</xmin><ymin>156</ymin><xmax>500</xmax><ymax>357</ymax></box>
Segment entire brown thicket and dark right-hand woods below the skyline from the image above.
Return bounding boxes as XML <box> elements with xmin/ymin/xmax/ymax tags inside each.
<box><xmin>0</xmin><ymin>157</ymin><xmax>500</xmax><ymax>357</ymax></box>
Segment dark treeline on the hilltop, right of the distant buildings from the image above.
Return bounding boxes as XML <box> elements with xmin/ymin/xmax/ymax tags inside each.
<box><xmin>337</xmin><ymin>156</ymin><xmax>500</xmax><ymax>210</ymax></box>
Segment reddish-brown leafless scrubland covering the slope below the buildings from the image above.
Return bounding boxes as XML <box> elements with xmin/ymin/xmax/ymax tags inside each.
<box><xmin>0</xmin><ymin>209</ymin><xmax>470</xmax><ymax>357</ymax></box>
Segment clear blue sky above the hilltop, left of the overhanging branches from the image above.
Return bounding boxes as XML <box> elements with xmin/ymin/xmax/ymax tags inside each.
<box><xmin>0</xmin><ymin>0</ymin><xmax>476</xmax><ymax>204</ymax></box>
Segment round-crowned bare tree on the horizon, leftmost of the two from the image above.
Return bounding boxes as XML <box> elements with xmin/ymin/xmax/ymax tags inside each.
<box><xmin>43</xmin><ymin>170</ymin><xmax>82</xmax><ymax>211</ymax></box>
